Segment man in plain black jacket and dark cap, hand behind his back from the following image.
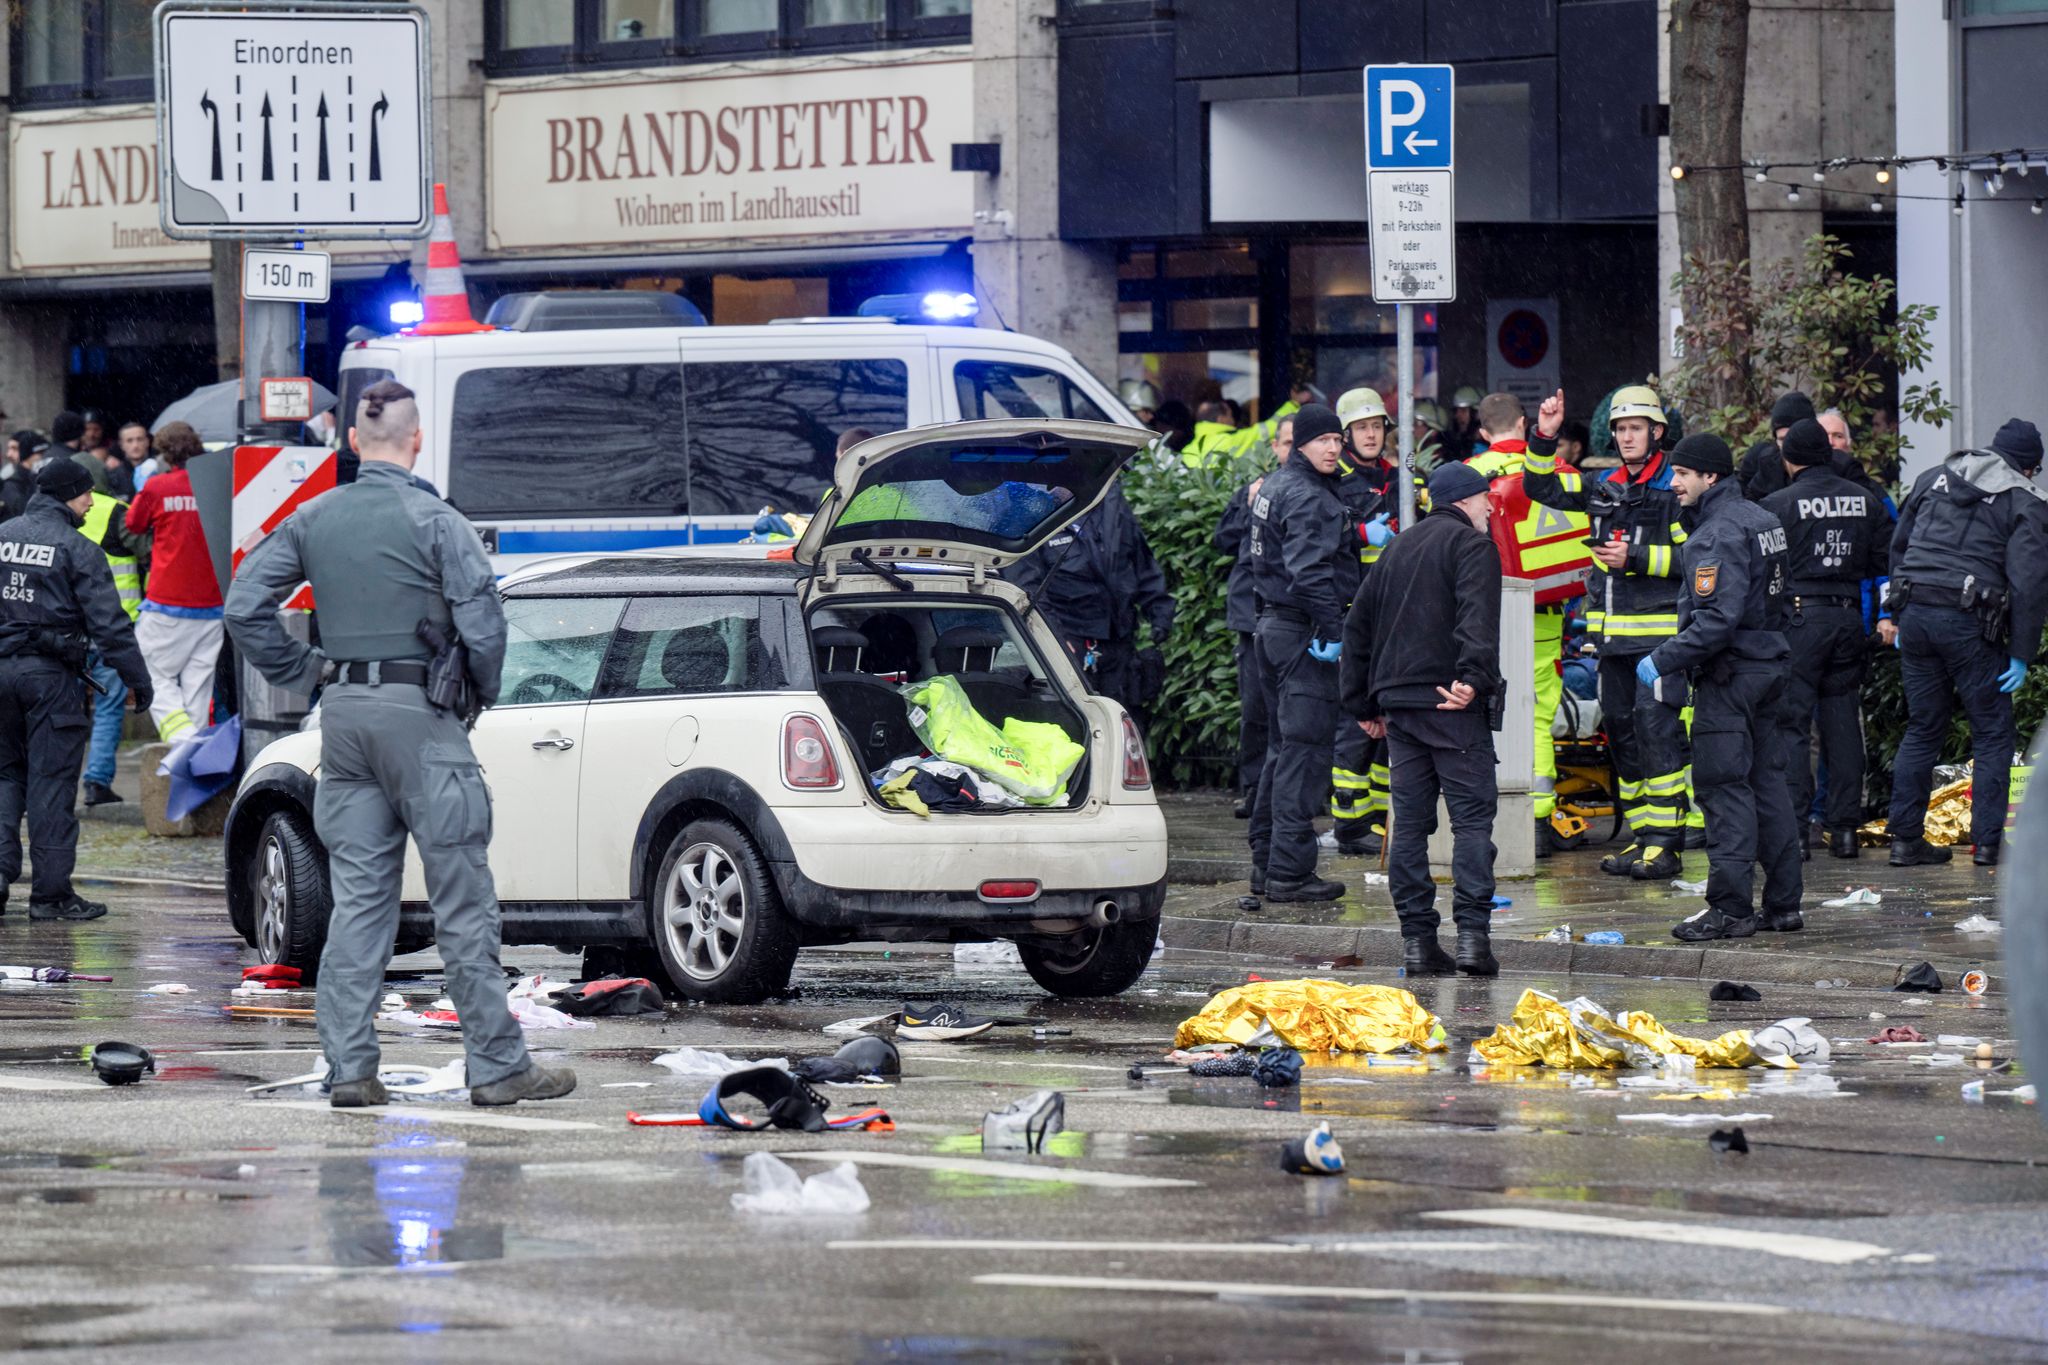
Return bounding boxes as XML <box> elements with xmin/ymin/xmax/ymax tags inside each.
<box><xmin>1343</xmin><ymin>463</ymin><xmax>1505</xmax><ymax>976</ymax></box>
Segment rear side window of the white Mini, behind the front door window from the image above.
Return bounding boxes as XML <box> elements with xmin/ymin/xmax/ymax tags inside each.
<box><xmin>598</xmin><ymin>598</ymin><xmax>795</xmax><ymax>698</ymax></box>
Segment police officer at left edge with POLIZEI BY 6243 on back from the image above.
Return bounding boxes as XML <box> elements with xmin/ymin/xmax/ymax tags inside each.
<box><xmin>0</xmin><ymin>460</ymin><xmax>152</xmax><ymax>919</ymax></box>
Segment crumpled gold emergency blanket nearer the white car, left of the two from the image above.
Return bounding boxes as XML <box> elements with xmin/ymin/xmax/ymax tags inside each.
<box><xmin>1174</xmin><ymin>980</ymin><xmax>1444</xmax><ymax>1052</ymax></box>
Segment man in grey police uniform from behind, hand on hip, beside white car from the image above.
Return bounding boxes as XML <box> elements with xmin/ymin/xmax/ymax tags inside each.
<box><xmin>227</xmin><ymin>381</ymin><xmax>575</xmax><ymax>1109</ymax></box>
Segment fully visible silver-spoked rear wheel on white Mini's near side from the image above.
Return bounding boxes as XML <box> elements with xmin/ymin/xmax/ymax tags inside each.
<box><xmin>647</xmin><ymin>821</ymin><xmax>797</xmax><ymax>1005</ymax></box>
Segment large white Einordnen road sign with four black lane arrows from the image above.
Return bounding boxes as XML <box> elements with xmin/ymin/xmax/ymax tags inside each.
<box><xmin>156</xmin><ymin>4</ymin><xmax>432</xmax><ymax>237</ymax></box>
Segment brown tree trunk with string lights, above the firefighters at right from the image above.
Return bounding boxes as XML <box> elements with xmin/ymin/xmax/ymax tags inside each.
<box><xmin>1671</xmin><ymin>0</ymin><xmax>1749</xmax><ymax>407</ymax></box>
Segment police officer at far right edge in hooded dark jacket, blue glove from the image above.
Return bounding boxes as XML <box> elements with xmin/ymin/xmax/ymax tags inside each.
<box><xmin>1875</xmin><ymin>417</ymin><xmax>2048</xmax><ymax>868</ymax></box>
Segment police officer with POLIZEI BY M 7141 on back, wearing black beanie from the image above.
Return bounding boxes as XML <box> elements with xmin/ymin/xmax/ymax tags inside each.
<box><xmin>1757</xmin><ymin>417</ymin><xmax>1892</xmax><ymax>857</ymax></box>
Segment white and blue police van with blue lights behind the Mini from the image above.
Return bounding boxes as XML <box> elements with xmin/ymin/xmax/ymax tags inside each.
<box><xmin>336</xmin><ymin>291</ymin><xmax>1139</xmax><ymax>573</ymax></box>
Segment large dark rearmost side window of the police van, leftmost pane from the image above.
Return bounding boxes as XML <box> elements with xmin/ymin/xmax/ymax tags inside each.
<box><xmin>449</xmin><ymin>364</ymin><xmax>688</xmax><ymax>518</ymax></box>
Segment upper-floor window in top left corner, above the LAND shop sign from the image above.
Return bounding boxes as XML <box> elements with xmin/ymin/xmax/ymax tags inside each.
<box><xmin>8</xmin><ymin>0</ymin><xmax>156</xmax><ymax>104</ymax></box>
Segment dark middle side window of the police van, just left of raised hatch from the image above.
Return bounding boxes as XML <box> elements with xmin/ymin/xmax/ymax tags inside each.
<box><xmin>684</xmin><ymin>360</ymin><xmax>909</xmax><ymax>518</ymax></box>
